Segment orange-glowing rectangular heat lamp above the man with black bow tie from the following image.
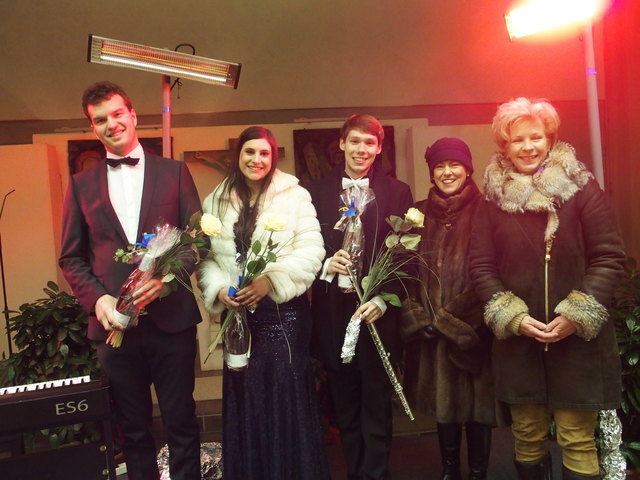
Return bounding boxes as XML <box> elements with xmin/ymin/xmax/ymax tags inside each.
<box><xmin>87</xmin><ymin>35</ymin><xmax>240</xmax><ymax>88</ymax></box>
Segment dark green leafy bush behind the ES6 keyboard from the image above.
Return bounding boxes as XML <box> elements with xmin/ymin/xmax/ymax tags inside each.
<box><xmin>0</xmin><ymin>282</ymin><xmax>99</xmax><ymax>450</ymax></box>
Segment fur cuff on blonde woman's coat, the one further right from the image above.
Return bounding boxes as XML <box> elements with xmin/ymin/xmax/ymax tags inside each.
<box><xmin>555</xmin><ymin>290</ymin><xmax>609</xmax><ymax>341</ymax></box>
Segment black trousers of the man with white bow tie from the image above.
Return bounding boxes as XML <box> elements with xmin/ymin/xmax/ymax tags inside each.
<box><xmin>327</xmin><ymin>348</ymin><xmax>393</xmax><ymax>480</ymax></box>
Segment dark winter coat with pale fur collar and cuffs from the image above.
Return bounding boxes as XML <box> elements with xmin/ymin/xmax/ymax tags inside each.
<box><xmin>470</xmin><ymin>143</ymin><xmax>625</xmax><ymax>410</ymax></box>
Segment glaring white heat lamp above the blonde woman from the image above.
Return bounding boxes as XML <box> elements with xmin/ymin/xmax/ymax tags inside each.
<box><xmin>505</xmin><ymin>0</ymin><xmax>597</xmax><ymax>40</ymax></box>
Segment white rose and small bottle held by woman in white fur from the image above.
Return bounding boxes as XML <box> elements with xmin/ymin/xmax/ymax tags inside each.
<box><xmin>205</xmin><ymin>215</ymin><xmax>285</xmax><ymax>370</ymax></box>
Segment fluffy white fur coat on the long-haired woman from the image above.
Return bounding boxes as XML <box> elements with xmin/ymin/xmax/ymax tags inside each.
<box><xmin>198</xmin><ymin>170</ymin><xmax>325</xmax><ymax>314</ymax></box>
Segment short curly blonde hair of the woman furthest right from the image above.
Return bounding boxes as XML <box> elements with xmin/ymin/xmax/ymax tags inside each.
<box><xmin>491</xmin><ymin>97</ymin><xmax>560</xmax><ymax>152</ymax></box>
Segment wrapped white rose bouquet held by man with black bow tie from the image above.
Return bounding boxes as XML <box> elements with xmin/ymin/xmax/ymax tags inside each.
<box><xmin>107</xmin><ymin>212</ymin><xmax>221</xmax><ymax>348</ymax></box>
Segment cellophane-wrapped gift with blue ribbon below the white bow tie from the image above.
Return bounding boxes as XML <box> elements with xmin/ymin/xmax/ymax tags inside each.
<box><xmin>334</xmin><ymin>186</ymin><xmax>376</xmax><ymax>293</ymax></box>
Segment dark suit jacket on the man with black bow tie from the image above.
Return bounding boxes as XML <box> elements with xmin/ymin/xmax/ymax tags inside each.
<box><xmin>58</xmin><ymin>153</ymin><xmax>201</xmax><ymax>340</ymax></box>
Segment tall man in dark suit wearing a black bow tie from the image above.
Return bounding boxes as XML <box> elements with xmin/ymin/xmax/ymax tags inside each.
<box><xmin>59</xmin><ymin>82</ymin><xmax>201</xmax><ymax>480</ymax></box>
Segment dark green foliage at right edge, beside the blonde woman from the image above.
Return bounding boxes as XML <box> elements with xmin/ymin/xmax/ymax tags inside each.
<box><xmin>612</xmin><ymin>258</ymin><xmax>640</xmax><ymax>468</ymax></box>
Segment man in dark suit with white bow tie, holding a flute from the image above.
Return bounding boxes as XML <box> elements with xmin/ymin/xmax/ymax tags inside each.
<box><xmin>309</xmin><ymin>115</ymin><xmax>413</xmax><ymax>480</ymax></box>
